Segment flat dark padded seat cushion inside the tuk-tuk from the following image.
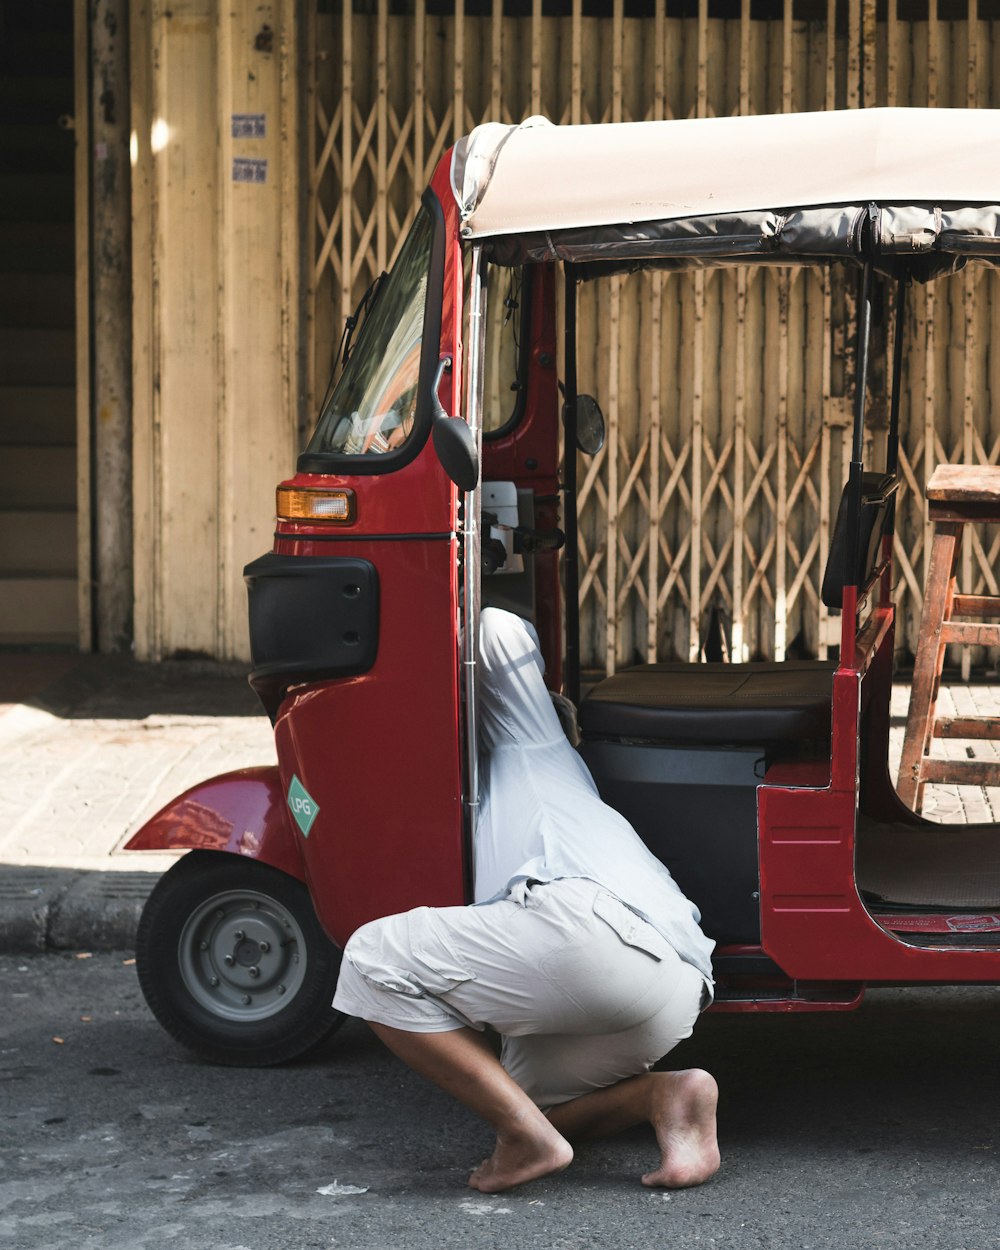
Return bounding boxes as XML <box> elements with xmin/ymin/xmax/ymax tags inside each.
<box><xmin>579</xmin><ymin>660</ymin><xmax>836</xmax><ymax>745</ymax></box>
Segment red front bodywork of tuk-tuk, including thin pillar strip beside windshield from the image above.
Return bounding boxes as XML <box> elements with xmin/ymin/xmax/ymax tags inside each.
<box><xmin>263</xmin><ymin>171</ymin><xmax>466</xmax><ymax>945</ymax></box>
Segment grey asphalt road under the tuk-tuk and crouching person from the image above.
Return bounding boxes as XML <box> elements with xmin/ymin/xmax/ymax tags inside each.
<box><xmin>0</xmin><ymin>955</ymin><xmax>1000</xmax><ymax>1250</ymax></box>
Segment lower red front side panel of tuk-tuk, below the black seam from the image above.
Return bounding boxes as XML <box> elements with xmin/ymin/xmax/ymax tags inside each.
<box><xmin>275</xmin><ymin>539</ymin><xmax>465</xmax><ymax>944</ymax></box>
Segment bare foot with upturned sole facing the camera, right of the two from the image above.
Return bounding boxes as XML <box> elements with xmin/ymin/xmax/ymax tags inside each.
<box><xmin>643</xmin><ymin>1068</ymin><xmax>720</xmax><ymax>1189</ymax></box>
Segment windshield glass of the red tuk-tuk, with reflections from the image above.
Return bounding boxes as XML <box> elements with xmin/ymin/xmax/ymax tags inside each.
<box><xmin>305</xmin><ymin>208</ymin><xmax>434</xmax><ymax>456</ymax></box>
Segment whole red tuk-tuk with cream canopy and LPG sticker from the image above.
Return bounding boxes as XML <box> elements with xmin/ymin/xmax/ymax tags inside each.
<box><xmin>129</xmin><ymin>109</ymin><xmax>1000</xmax><ymax>1064</ymax></box>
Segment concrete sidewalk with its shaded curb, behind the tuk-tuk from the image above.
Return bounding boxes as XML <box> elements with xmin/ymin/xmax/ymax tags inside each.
<box><xmin>0</xmin><ymin>653</ymin><xmax>1000</xmax><ymax>953</ymax></box>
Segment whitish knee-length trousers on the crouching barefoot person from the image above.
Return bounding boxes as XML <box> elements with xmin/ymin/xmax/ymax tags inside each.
<box><xmin>334</xmin><ymin>878</ymin><xmax>709</xmax><ymax>1108</ymax></box>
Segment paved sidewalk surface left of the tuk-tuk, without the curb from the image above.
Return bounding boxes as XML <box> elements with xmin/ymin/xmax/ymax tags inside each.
<box><xmin>0</xmin><ymin>665</ymin><xmax>275</xmax><ymax>871</ymax></box>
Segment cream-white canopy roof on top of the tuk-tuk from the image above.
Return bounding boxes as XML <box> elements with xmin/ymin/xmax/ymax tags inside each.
<box><xmin>453</xmin><ymin>109</ymin><xmax>1000</xmax><ymax>239</ymax></box>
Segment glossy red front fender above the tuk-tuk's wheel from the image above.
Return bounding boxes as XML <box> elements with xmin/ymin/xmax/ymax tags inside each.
<box><xmin>125</xmin><ymin>765</ymin><xmax>305</xmax><ymax>881</ymax></box>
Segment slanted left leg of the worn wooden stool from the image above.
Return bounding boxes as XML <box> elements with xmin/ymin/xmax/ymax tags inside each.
<box><xmin>896</xmin><ymin>521</ymin><xmax>961</xmax><ymax>811</ymax></box>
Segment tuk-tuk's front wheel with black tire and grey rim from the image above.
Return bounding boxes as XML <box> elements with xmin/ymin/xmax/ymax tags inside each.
<box><xmin>135</xmin><ymin>851</ymin><xmax>344</xmax><ymax>1068</ymax></box>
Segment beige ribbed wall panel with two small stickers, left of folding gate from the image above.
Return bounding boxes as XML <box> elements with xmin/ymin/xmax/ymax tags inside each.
<box><xmin>131</xmin><ymin>0</ymin><xmax>299</xmax><ymax>659</ymax></box>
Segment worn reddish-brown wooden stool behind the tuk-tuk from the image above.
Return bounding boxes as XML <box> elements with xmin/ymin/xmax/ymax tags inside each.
<box><xmin>896</xmin><ymin>465</ymin><xmax>1000</xmax><ymax>811</ymax></box>
